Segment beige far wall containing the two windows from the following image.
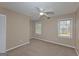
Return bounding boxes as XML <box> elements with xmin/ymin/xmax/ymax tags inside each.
<box><xmin>32</xmin><ymin>13</ymin><xmax>75</xmax><ymax>47</ymax></box>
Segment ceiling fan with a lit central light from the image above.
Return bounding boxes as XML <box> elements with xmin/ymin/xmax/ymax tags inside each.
<box><xmin>36</xmin><ymin>7</ymin><xmax>54</xmax><ymax>19</ymax></box>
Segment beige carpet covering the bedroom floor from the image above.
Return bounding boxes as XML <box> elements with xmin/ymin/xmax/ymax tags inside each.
<box><xmin>7</xmin><ymin>39</ymin><xmax>77</xmax><ymax>56</ymax></box>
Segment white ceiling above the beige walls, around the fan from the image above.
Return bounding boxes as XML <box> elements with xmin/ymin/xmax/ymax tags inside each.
<box><xmin>0</xmin><ymin>2</ymin><xmax>79</xmax><ymax>20</ymax></box>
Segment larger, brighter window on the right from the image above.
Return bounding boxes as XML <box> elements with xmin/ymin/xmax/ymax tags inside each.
<box><xmin>58</xmin><ymin>19</ymin><xmax>72</xmax><ymax>37</ymax></box>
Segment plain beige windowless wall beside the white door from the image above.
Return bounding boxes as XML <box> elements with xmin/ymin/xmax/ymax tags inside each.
<box><xmin>0</xmin><ymin>7</ymin><xmax>30</xmax><ymax>50</ymax></box>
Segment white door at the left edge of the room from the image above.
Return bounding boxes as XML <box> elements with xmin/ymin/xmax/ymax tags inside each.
<box><xmin>0</xmin><ymin>14</ymin><xmax>6</xmax><ymax>53</ymax></box>
